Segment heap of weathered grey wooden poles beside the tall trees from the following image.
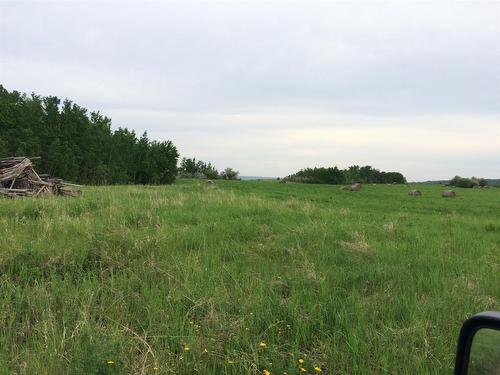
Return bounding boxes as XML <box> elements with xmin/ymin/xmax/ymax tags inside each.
<box><xmin>0</xmin><ymin>156</ymin><xmax>82</xmax><ymax>198</ymax></box>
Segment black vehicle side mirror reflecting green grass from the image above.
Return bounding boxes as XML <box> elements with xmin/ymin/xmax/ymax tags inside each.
<box><xmin>454</xmin><ymin>311</ymin><xmax>500</xmax><ymax>375</ymax></box>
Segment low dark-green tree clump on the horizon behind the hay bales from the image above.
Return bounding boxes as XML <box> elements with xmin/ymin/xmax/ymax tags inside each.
<box><xmin>284</xmin><ymin>165</ymin><xmax>406</xmax><ymax>185</ymax></box>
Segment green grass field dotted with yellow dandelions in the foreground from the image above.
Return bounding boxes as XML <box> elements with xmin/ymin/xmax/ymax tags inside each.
<box><xmin>0</xmin><ymin>181</ymin><xmax>500</xmax><ymax>375</ymax></box>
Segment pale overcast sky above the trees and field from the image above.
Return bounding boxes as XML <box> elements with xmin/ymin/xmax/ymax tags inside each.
<box><xmin>0</xmin><ymin>0</ymin><xmax>500</xmax><ymax>180</ymax></box>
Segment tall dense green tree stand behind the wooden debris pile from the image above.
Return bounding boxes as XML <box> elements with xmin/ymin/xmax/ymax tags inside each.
<box><xmin>0</xmin><ymin>85</ymin><xmax>179</xmax><ymax>184</ymax></box>
